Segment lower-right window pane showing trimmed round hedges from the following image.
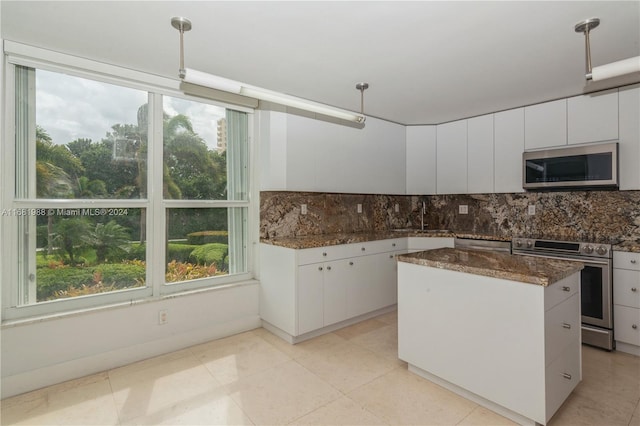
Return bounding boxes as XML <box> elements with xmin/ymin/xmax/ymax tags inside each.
<box><xmin>165</xmin><ymin>208</ymin><xmax>247</xmax><ymax>283</ymax></box>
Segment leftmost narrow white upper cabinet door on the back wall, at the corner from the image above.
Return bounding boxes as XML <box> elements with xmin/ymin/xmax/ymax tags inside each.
<box><xmin>406</xmin><ymin>126</ymin><xmax>436</xmax><ymax>195</ymax></box>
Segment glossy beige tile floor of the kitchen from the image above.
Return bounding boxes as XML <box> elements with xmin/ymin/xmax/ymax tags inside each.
<box><xmin>0</xmin><ymin>312</ymin><xmax>640</xmax><ymax>426</ymax></box>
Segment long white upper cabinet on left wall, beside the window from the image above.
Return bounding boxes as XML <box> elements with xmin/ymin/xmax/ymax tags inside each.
<box><xmin>257</xmin><ymin>111</ymin><xmax>406</xmax><ymax>194</ymax></box>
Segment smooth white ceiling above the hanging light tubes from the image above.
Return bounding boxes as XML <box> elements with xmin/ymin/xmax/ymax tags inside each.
<box><xmin>0</xmin><ymin>0</ymin><xmax>640</xmax><ymax>125</ymax></box>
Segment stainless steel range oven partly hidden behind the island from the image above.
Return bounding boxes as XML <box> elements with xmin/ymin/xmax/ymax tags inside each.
<box><xmin>512</xmin><ymin>238</ymin><xmax>614</xmax><ymax>350</ymax></box>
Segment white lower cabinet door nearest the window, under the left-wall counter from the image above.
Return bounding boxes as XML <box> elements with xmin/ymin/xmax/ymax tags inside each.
<box><xmin>297</xmin><ymin>263</ymin><xmax>324</xmax><ymax>335</ymax></box>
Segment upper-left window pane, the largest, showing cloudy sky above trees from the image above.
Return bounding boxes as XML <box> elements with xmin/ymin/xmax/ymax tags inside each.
<box><xmin>30</xmin><ymin>70</ymin><xmax>148</xmax><ymax>199</ymax></box>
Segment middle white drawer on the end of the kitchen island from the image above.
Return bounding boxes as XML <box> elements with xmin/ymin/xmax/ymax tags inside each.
<box><xmin>544</xmin><ymin>293</ymin><xmax>580</xmax><ymax>365</ymax></box>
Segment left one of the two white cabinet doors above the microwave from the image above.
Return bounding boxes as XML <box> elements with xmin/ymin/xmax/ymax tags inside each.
<box><xmin>524</xmin><ymin>99</ymin><xmax>567</xmax><ymax>150</ymax></box>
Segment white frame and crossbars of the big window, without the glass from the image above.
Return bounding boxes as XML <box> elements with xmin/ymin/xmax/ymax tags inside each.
<box><xmin>0</xmin><ymin>41</ymin><xmax>259</xmax><ymax>323</ymax></box>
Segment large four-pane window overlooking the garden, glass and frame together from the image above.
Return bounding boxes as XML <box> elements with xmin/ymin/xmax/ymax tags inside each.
<box><xmin>1</xmin><ymin>60</ymin><xmax>250</xmax><ymax>318</ymax></box>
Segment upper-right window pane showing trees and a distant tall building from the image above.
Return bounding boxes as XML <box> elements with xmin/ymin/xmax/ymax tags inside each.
<box><xmin>163</xmin><ymin>96</ymin><xmax>227</xmax><ymax>200</ymax></box>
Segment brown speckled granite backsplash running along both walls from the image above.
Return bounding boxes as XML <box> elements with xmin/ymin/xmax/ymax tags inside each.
<box><xmin>260</xmin><ymin>191</ymin><xmax>640</xmax><ymax>243</ymax></box>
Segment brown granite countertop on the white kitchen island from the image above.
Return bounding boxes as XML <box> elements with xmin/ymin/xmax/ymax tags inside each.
<box><xmin>398</xmin><ymin>248</ymin><xmax>584</xmax><ymax>286</ymax></box>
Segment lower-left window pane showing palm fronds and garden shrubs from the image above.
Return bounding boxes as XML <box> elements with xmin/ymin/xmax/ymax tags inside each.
<box><xmin>29</xmin><ymin>208</ymin><xmax>146</xmax><ymax>302</ymax></box>
